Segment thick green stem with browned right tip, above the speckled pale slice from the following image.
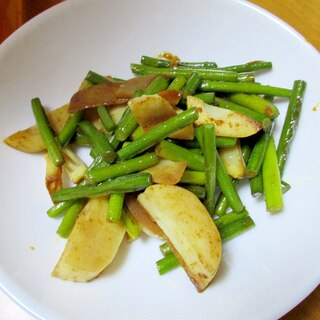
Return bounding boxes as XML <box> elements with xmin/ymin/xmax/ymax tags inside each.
<box><xmin>229</xmin><ymin>93</ymin><xmax>279</xmax><ymax>119</ymax></box>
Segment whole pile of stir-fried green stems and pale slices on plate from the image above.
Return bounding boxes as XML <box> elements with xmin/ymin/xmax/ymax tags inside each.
<box><xmin>4</xmin><ymin>53</ymin><xmax>306</xmax><ymax>292</ymax></box>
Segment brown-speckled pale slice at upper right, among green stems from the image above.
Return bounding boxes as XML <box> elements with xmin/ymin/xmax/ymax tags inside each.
<box><xmin>187</xmin><ymin>96</ymin><xmax>262</xmax><ymax>138</ymax></box>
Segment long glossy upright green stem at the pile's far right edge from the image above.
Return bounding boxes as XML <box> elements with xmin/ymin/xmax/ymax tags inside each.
<box><xmin>277</xmin><ymin>80</ymin><xmax>306</xmax><ymax>176</ymax></box>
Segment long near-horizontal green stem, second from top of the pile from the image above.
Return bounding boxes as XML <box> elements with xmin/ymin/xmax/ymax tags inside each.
<box><xmin>131</xmin><ymin>64</ymin><xmax>239</xmax><ymax>82</ymax></box>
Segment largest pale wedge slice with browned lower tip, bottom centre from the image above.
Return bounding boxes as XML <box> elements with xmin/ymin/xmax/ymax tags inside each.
<box><xmin>138</xmin><ymin>184</ymin><xmax>222</xmax><ymax>292</ymax></box>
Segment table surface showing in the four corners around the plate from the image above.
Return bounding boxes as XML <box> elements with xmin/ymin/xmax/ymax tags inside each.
<box><xmin>0</xmin><ymin>0</ymin><xmax>320</xmax><ymax>320</ymax></box>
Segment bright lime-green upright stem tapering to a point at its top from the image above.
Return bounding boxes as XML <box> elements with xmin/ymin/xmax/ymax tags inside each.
<box><xmin>262</xmin><ymin>137</ymin><xmax>283</xmax><ymax>212</ymax></box>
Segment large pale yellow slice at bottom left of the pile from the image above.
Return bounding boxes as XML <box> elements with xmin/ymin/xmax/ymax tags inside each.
<box><xmin>52</xmin><ymin>198</ymin><xmax>125</xmax><ymax>282</ymax></box>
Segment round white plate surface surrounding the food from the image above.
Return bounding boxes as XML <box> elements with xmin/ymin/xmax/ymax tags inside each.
<box><xmin>0</xmin><ymin>0</ymin><xmax>320</xmax><ymax>320</ymax></box>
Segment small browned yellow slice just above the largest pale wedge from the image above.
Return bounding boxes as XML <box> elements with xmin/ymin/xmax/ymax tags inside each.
<box><xmin>143</xmin><ymin>159</ymin><xmax>187</xmax><ymax>185</ymax></box>
